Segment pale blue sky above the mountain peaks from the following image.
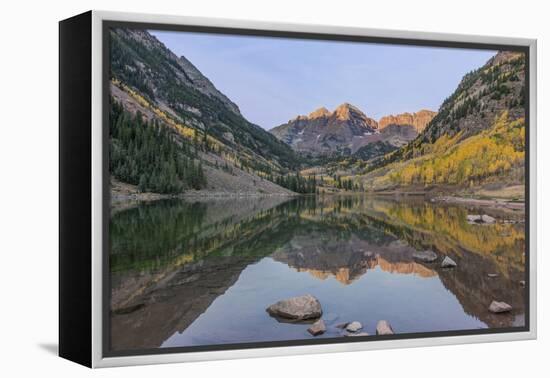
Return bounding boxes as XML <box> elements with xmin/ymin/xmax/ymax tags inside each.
<box><xmin>150</xmin><ymin>30</ymin><xmax>496</xmax><ymax>129</ymax></box>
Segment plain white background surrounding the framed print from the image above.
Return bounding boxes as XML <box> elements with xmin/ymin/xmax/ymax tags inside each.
<box><xmin>0</xmin><ymin>0</ymin><xmax>550</xmax><ymax>378</ymax></box>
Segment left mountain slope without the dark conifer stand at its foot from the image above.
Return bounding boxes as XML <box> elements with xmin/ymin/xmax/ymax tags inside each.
<box><xmin>111</xmin><ymin>29</ymin><xmax>300</xmax><ymax>193</ymax></box>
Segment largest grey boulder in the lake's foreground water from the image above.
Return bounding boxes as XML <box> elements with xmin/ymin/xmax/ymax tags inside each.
<box><xmin>266</xmin><ymin>294</ymin><xmax>323</xmax><ymax>320</ymax></box>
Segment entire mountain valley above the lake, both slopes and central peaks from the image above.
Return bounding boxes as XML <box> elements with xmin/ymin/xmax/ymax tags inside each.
<box><xmin>110</xmin><ymin>29</ymin><xmax>525</xmax><ymax>200</ymax></box>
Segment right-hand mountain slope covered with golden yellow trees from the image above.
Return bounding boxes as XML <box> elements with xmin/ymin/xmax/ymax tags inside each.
<box><xmin>361</xmin><ymin>52</ymin><xmax>525</xmax><ymax>190</ymax></box>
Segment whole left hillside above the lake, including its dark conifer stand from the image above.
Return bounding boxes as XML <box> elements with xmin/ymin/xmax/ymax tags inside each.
<box><xmin>110</xmin><ymin>29</ymin><xmax>300</xmax><ymax>193</ymax></box>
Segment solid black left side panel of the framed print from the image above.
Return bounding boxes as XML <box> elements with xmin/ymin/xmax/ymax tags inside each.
<box><xmin>58</xmin><ymin>11</ymin><xmax>93</xmax><ymax>367</ymax></box>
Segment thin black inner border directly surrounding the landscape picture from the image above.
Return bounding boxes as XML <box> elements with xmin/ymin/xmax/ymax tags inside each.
<box><xmin>101</xmin><ymin>20</ymin><xmax>531</xmax><ymax>358</ymax></box>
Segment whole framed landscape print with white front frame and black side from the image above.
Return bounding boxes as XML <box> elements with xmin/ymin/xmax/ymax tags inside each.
<box><xmin>59</xmin><ymin>11</ymin><xmax>536</xmax><ymax>367</ymax></box>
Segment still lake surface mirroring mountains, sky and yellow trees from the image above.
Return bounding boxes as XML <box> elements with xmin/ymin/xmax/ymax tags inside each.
<box><xmin>110</xmin><ymin>196</ymin><xmax>525</xmax><ymax>351</ymax></box>
